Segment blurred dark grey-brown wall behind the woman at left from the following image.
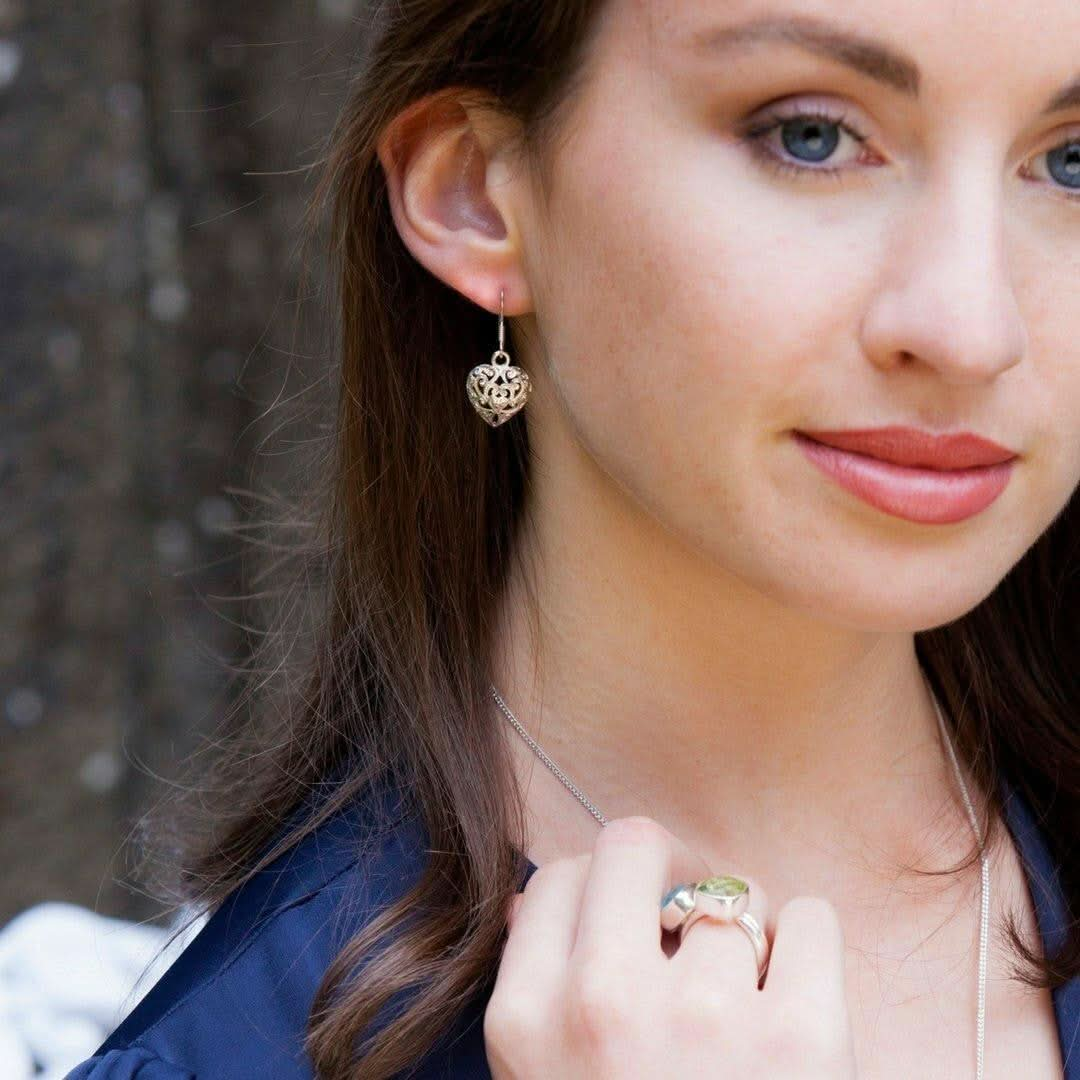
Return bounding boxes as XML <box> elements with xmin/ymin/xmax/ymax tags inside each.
<box><xmin>0</xmin><ymin>0</ymin><xmax>355</xmax><ymax>924</ymax></box>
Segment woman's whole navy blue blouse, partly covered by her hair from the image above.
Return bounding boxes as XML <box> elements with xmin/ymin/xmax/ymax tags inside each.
<box><xmin>66</xmin><ymin>783</ymin><xmax>1080</xmax><ymax>1080</ymax></box>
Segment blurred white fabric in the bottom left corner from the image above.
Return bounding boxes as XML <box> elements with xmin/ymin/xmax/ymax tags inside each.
<box><xmin>0</xmin><ymin>902</ymin><xmax>205</xmax><ymax>1080</ymax></box>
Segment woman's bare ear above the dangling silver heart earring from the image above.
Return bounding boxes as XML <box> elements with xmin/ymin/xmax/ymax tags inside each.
<box><xmin>377</xmin><ymin>92</ymin><xmax>532</xmax><ymax>315</ymax></box>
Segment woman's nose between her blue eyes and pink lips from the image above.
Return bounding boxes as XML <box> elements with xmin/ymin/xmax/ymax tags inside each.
<box><xmin>861</xmin><ymin>148</ymin><xmax>1027</xmax><ymax>384</ymax></box>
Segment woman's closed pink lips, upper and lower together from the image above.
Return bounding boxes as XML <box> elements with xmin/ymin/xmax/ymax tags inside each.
<box><xmin>792</xmin><ymin>427</ymin><xmax>1017</xmax><ymax>524</ymax></box>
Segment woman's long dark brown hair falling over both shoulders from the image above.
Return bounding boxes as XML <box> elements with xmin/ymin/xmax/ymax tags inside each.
<box><xmin>141</xmin><ymin>0</ymin><xmax>1080</xmax><ymax>1080</ymax></box>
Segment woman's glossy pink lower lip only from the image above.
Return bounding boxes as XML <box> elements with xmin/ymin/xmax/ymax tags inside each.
<box><xmin>793</xmin><ymin>431</ymin><xmax>1015</xmax><ymax>525</ymax></box>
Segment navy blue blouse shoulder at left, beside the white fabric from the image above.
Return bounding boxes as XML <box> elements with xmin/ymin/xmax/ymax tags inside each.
<box><xmin>67</xmin><ymin>786</ymin><xmax>427</xmax><ymax>1080</ymax></box>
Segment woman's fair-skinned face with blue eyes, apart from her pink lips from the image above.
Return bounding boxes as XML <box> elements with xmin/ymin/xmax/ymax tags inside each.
<box><xmin>514</xmin><ymin>0</ymin><xmax>1080</xmax><ymax>630</ymax></box>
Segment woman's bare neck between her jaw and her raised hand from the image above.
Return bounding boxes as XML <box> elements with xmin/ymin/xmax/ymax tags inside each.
<box><xmin>495</xmin><ymin>442</ymin><xmax>974</xmax><ymax>907</ymax></box>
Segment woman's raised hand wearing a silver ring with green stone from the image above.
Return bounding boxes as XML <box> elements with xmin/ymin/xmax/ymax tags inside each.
<box><xmin>484</xmin><ymin>816</ymin><xmax>855</xmax><ymax>1080</ymax></box>
